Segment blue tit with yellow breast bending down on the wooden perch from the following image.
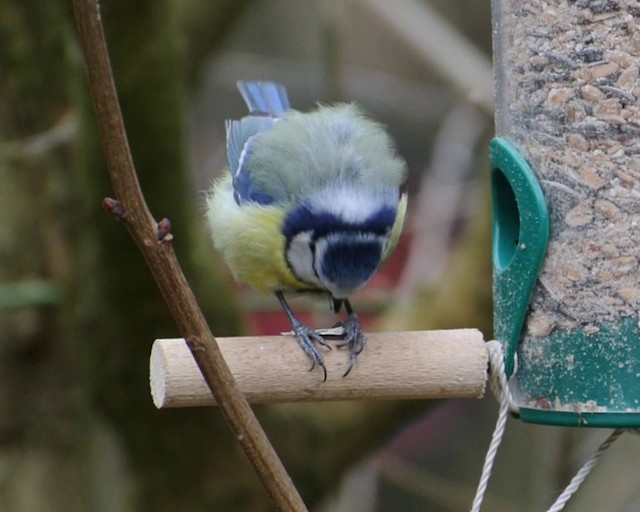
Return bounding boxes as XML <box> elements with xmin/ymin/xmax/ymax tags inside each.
<box><xmin>206</xmin><ymin>81</ymin><xmax>407</xmax><ymax>380</ymax></box>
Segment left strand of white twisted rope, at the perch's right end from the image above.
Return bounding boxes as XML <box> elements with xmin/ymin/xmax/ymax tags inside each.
<box><xmin>471</xmin><ymin>341</ymin><xmax>518</xmax><ymax>512</ymax></box>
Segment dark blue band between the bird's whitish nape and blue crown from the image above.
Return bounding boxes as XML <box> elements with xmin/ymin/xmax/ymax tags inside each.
<box><xmin>282</xmin><ymin>205</ymin><xmax>396</xmax><ymax>240</ymax></box>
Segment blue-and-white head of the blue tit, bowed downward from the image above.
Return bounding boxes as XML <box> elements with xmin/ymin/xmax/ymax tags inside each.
<box><xmin>283</xmin><ymin>187</ymin><xmax>398</xmax><ymax>299</ymax></box>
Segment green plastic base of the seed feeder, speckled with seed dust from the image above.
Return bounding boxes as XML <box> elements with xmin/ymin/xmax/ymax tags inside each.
<box><xmin>513</xmin><ymin>317</ymin><xmax>640</xmax><ymax>428</ymax></box>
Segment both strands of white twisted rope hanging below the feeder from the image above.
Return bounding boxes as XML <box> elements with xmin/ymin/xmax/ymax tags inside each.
<box><xmin>471</xmin><ymin>341</ymin><xmax>640</xmax><ymax>512</ymax></box>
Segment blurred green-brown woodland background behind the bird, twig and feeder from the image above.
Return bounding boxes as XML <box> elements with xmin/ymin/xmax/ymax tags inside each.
<box><xmin>0</xmin><ymin>0</ymin><xmax>640</xmax><ymax>512</ymax></box>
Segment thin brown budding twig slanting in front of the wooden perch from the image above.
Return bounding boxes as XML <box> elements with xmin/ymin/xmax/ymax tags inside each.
<box><xmin>73</xmin><ymin>0</ymin><xmax>306</xmax><ymax>511</ymax></box>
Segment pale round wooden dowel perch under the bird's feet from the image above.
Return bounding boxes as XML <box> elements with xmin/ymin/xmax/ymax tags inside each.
<box><xmin>150</xmin><ymin>329</ymin><xmax>488</xmax><ymax>408</ymax></box>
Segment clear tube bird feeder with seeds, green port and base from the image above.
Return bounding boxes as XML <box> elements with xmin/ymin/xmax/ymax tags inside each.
<box><xmin>490</xmin><ymin>0</ymin><xmax>640</xmax><ymax>427</ymax></box>
